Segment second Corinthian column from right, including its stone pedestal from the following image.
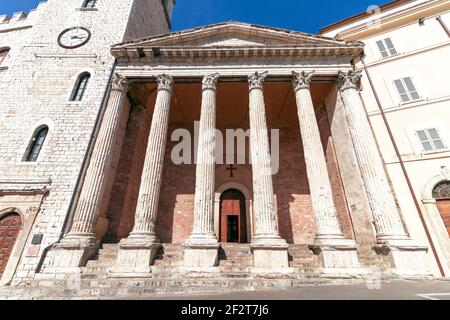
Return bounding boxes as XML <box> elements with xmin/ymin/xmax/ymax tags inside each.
<box><xmin>293</xmin><ymin>71</ymin><xmax>359</xmax><ymax>273</ymax></box>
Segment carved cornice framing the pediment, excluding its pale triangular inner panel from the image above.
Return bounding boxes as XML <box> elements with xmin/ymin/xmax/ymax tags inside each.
<box><xmin>111</xmin><ymin>22</ymin><xmax>364</xmax><ymax>59</ymax></box>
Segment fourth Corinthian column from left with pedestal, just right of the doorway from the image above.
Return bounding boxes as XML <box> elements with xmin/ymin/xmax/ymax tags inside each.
<box><xmin>248</xmin><ymin>72</ymin><xmax>288</xmax><ymax>267</ymax></box>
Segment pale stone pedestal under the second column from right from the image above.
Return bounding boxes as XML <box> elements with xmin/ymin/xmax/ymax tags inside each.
<box><xmin>309</xmin><ymin>238</ymin><xmax>368</xmax><ymax>275</ymax></box>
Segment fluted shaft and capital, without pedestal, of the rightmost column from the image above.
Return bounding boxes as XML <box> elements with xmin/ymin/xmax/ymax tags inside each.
<box><xmin>338</xmin><ymin>71</ymin><xmax>407</xmax><ymax>240</ymax></box>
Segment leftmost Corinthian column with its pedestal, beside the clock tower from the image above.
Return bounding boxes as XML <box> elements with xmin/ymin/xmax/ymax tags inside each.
<box><xmin>53</xmin><ymin>74</ymin><xmax>129</xmax><ymax>267</ymax></box>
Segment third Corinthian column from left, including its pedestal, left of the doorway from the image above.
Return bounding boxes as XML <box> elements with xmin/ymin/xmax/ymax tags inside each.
<box><xmin>184</xmin><ymin>73</ymin><xmax>219</xmax><ymax>267</ymax></box>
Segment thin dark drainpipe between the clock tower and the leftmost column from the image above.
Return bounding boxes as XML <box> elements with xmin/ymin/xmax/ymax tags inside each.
<box><xmin>35</xmin><ymin>59</ymin><xmax>117</xmax><ymax>273</ymax></box>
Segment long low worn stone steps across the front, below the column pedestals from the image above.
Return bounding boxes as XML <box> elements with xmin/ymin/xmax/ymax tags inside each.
<box><xmin>0</xmin><ymin>274</ymin><xmax>368</xmax><ymax>299</ymax></box>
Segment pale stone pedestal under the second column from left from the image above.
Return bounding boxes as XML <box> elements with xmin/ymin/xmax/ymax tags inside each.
<box><xmin>110</xmin><ymin>236</ymin><xmax>161</xmax><ymax>274</ymax></box>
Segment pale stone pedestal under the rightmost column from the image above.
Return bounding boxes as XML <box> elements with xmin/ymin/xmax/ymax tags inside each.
<box><xmin>375</xmin><ymin>239</ymin><xmax>432</xmax><ymax>277</ymax></box>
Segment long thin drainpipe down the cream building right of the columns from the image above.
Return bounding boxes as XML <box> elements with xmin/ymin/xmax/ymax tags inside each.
<box><xmin>361</xmin><ymin>55</ymin><xmax>445</xmax><ymax>277</ymax></box>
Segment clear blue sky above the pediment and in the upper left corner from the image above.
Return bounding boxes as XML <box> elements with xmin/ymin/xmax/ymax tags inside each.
<box><xmin>0</xmin><ymin>0</ymin><xmax>389</xmax><ymax>33</ymax></box>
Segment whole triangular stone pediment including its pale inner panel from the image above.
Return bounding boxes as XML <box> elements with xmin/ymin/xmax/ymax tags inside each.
<box><xmin>111</xmin><ymin>22</ymin><xmax>364</xmax><ymax>58</ymax></box>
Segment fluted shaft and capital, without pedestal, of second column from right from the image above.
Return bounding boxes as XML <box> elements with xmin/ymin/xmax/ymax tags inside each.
<box><xmin>293</xmin><ymin>72</ymin><xmax>343</xmax><ymax>239</ymax></box>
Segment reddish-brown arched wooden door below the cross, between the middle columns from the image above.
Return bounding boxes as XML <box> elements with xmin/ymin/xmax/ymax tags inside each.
<box><xmin>219</xmin><ymin>189</ymin><xmax>247</xmax><ymax>243</ymax></box>
